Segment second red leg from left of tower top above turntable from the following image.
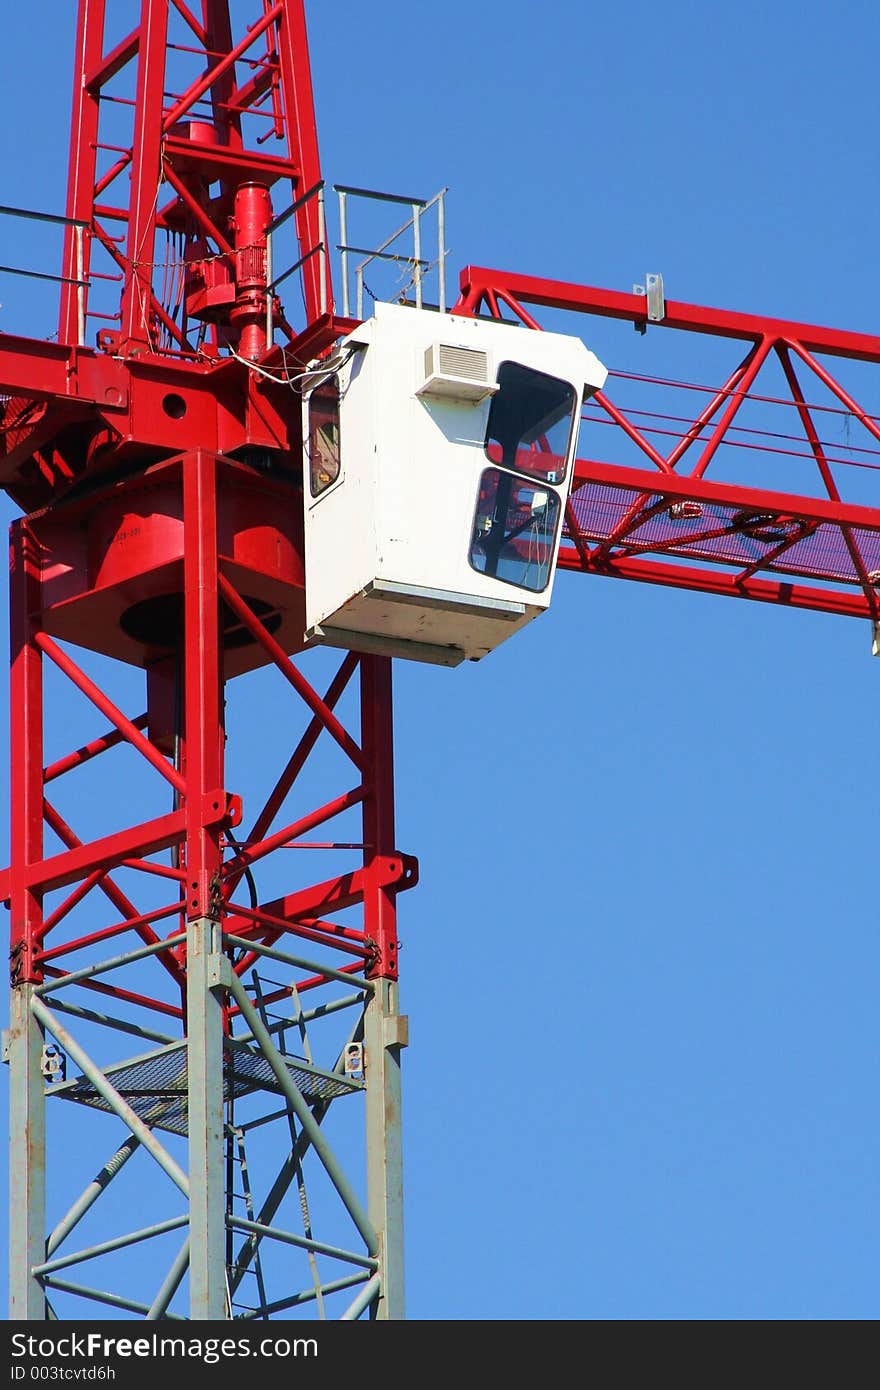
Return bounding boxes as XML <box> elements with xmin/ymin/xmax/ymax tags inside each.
<box><xmin>121</xmin><ymin>4</ymin><xmax>168</xmax><ymax>350</ymax></box>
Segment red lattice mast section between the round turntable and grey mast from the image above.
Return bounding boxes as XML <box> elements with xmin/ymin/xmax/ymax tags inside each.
<box><xmin>0</xmin><ymin>452</ymin><xmax>417</xmax><ymax>1012</ymax></box>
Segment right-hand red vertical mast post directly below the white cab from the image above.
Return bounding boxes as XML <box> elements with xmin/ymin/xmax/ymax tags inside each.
<box><xmin>360</xmin><ymin>656</ymin><xmax>398</xmax><ymax>980</ymax></box>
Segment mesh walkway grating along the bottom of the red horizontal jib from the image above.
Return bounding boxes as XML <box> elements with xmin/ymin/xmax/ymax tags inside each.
<box><xmin>571</xmin><ymin>484</ymin><xmax>880</xmax><ymax>584</ymax></box>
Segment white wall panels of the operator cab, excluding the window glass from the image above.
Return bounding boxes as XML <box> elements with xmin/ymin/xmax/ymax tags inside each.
<box><xmin>304</xmin><ymin>304</ymin><xmax>605</xmax><ymax>663</ymax></box>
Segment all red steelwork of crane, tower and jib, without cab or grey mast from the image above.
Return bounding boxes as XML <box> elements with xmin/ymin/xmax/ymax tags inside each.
<box><xmin>0</xmin><ymin>0</ymin><xmax>880</xmax><ymax>1167</ymax></box>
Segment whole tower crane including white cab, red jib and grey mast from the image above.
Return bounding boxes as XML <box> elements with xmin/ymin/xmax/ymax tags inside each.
<box><xmin>0</xmin><ymin>0</ymin><xmax>880</xmax><ymax>1319</ymax></box>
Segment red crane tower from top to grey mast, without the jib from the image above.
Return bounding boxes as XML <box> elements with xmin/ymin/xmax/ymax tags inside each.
<box><xmin>0</xmin><ymin>8</ymin><xmax>417</xmax><ymax>1045</ymax></box>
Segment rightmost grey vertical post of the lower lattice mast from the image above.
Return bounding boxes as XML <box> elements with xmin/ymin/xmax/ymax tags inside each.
<box><xmin>364</xmin><ymin>980</ymin><xmax>406</xmax><ymax>1321</ymax></box>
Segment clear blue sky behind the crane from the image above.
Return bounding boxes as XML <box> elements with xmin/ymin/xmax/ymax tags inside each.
<box><xmin>0</xmin><ymin>0</ymin><xmax>880</xmax><ymax>1321</ymax></box>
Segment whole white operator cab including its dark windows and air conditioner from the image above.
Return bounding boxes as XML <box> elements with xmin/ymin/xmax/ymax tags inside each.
<box><xmin>303</xmin><ymin>303</ymin><xmax>606</xmax><ymax>666</ymax></box>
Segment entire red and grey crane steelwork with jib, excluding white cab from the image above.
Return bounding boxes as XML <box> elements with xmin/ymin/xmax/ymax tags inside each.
<box><xmin>0</xmin><ymin>0</ymin><xmax>880</xmax><ymax>1318</ymax></box>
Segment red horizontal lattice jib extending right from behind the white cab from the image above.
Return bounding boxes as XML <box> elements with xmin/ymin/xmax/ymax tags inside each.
<box><xmin>455</xmin><ymin>267</ymin><xmax>880</xmax><ymax>621</ymax></box>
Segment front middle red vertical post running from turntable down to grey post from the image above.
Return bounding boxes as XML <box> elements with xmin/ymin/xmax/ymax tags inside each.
<box><xmin>184</xmin><ymin>450</ymin><xmax>224</xmax><ymax>920</ymax></box>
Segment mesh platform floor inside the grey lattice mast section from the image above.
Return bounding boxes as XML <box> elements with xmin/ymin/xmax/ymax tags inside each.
<box><xmin>46</xmin><ymin>1043</ymin><xmax>361</xmax><ymax>1134</ymax></box>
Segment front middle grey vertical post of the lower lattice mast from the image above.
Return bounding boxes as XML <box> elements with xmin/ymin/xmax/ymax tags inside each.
<box><xmin>186</xmin><ymin>917</ymin><xmax>229</xmax><ymax>1322</ymax></box>
